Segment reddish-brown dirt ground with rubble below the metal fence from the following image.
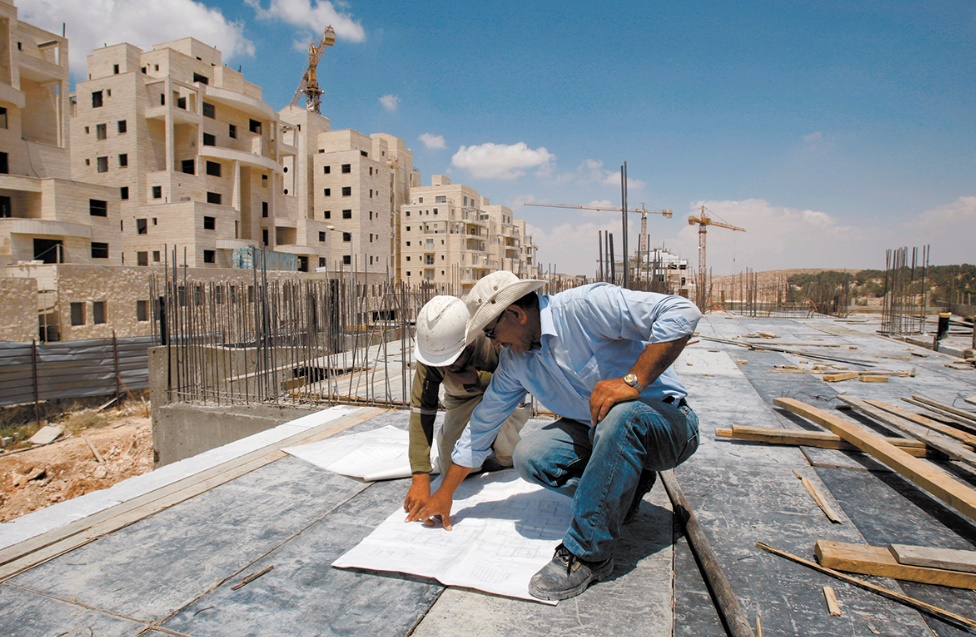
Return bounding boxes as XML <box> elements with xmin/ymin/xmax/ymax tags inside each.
<box><xmin>0</xmin><ymin>407</ymin><xmax>153</xmax><ymax>522</ymax></box>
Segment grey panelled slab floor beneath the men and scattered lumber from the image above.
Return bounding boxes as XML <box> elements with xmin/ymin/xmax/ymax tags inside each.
<box><xmin>0</xmin><ymin>315</ymin><xmax>976</xmax><ymax>637</ymax></box>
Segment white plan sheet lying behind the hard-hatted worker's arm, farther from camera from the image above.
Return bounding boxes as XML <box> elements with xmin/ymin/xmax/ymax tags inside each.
<box><xmin>284</xmin><ymin>425</ymin><xmax>437</xmax><ymax>481</ymax></box>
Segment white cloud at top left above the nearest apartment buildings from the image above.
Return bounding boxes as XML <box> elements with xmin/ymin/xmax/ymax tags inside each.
<box><xmin>17</xmin><ymin>0</ymin><xmax>254</xmax><ymax>79</ymax></box>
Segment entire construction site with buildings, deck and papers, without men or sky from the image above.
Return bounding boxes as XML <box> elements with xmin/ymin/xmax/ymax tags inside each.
<box><xmin>0</xmin><ymin>0</ymin><xmax>976</xmax><ymax>637</ymax></box>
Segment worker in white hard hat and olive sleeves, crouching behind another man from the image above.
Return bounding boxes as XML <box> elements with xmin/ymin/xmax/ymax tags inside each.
<box><xmin>403</xmin><ymin>296</ymin><xmax>528</xmax><ymax>515</ymax></box>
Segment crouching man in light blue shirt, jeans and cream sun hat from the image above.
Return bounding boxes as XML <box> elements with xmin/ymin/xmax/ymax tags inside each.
<box><xmin>408</xmin><ymin>272</ymin><xmax>701</xmax><ymax>600</ymax></box>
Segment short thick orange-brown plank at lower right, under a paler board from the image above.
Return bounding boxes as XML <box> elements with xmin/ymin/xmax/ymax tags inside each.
<box><xmin>814</xmin><ymin>540</ymin><xmax>976</xmax><ymax>590</ymax></box>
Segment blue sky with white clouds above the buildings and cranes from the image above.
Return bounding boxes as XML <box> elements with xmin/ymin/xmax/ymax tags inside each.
<box><xmin>17</xmin><ymin>0</ymin><xmax>976</xmax><ymax>275</ymax></box>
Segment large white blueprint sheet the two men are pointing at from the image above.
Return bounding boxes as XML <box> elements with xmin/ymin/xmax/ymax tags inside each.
<box><xmin>332</xmin><ymin>470</ymin><xmax>572</xmax><ymax>604</ymax></box>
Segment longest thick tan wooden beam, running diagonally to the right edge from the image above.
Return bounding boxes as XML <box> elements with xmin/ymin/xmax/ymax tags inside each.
<box><xmin>773</xmin><ymin>398</ymin><xmax>976</xmax><ymax>520</ymax></box>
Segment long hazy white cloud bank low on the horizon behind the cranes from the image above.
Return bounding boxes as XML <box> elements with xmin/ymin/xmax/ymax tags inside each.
<box><xmin>528</xmin><ymin>196</ymin><xmax>976</xmax><ymax>276</ymax></box>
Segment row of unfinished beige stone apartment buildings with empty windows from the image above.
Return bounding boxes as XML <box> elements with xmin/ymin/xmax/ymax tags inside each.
<box><xmin>0</xmin><ymin>0</ymin><xmax>539</xmax><ymax>341</ymax></box>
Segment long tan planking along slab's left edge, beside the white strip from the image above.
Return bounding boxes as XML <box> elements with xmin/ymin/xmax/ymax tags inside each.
<box><xmin>0</xmin><ymin>408</ymin><xmax>388</xmax><ymax>582</ymax></box>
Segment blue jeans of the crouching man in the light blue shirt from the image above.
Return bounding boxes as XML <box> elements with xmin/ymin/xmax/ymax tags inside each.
<box><xmin>513</xmin><ymin>401</ymin><xmax>698</xmax><ymax>561</ymax></box>
